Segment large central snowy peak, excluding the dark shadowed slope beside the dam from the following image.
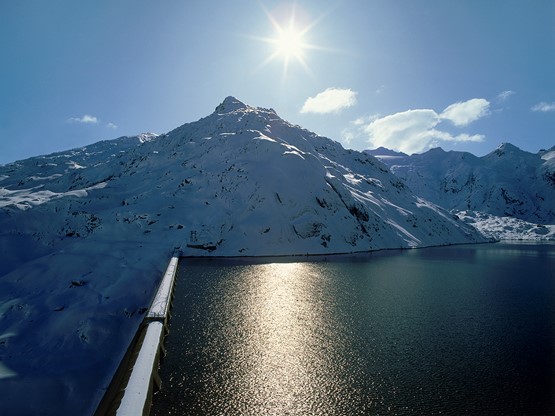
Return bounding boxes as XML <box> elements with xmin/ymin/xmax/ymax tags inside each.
<box><xmin>0</xmin><ymin>97</ymin><xmax>484</xmax><ymax>255</ymax></box>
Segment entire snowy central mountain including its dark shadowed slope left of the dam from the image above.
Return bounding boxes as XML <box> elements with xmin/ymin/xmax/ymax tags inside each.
<box><xmin>0</xmin><ymin>97</ymin><xmax>485</xmax><ymax>415</ymax></box>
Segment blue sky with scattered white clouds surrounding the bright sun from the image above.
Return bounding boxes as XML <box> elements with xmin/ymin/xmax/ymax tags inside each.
<box><xmin>0</xmin><ymin>0</ymin><xmax>555</xmax><ymax>163</ymax></box>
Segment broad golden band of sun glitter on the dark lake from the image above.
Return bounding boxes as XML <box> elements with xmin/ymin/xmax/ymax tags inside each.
<box><xmin>202</xmin><ymin>263</ymin><xmax>372</xmax><ymax>415</ymax></box>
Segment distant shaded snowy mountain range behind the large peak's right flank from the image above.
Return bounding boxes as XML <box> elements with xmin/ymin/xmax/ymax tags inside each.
<box><xmin>372</xmin><ymin>143</ymin><xmax>555</xmax><ymax>224</ymax></box>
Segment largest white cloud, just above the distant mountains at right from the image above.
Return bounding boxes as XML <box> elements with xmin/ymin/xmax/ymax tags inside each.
<box><xmin>348</xmin><ymin>99</ymin><xmax>489</xmax><ymax>154</ymax></box>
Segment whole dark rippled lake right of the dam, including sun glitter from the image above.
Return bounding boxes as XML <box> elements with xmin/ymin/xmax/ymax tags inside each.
<box><xmin>152</xmin><ymin>243</ymin><xmax>555</xmax><ymax>415</ymax></box>
